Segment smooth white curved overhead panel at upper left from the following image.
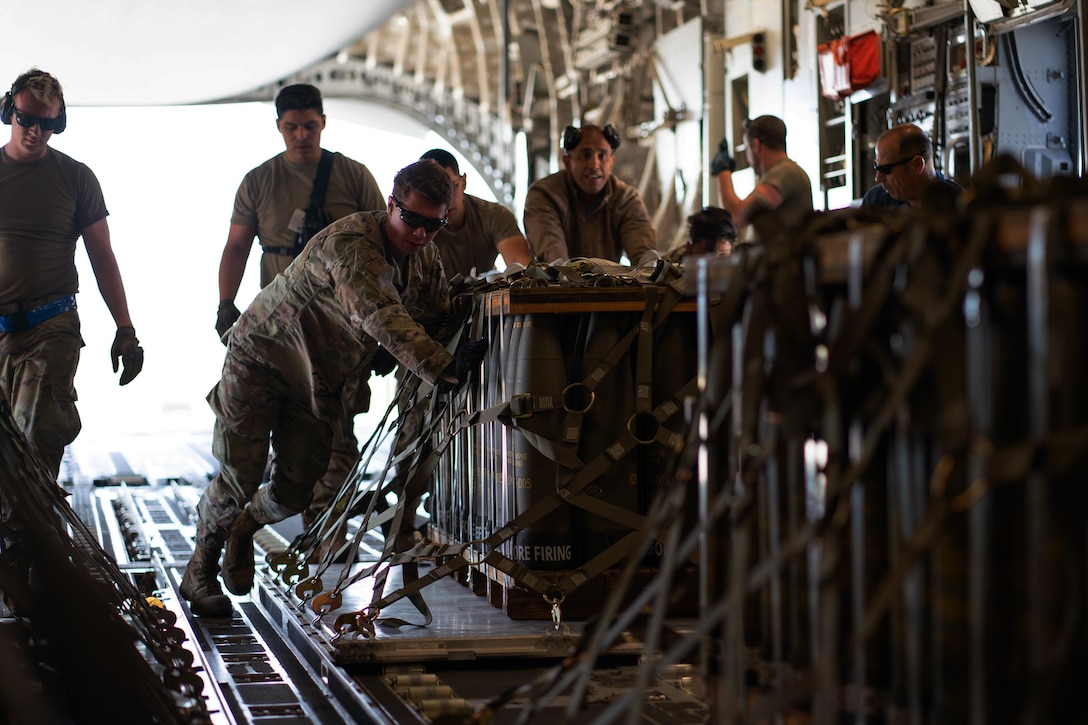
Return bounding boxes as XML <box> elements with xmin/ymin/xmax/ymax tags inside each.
<box><xmin>0</xmin><ymin>0</ymin><xmax>413</xmax><ymax>106</ymax></box>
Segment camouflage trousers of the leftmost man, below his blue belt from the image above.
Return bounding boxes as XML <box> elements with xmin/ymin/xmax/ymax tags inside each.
<box><xmin>0</xmin><ymin>310</ymin><xmax>83</xmax><ymax>476</ymax></box>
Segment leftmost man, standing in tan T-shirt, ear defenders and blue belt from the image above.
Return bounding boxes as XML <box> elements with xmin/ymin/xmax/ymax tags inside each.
<box><xmin>0</xmin><ymin>69</ymin><xmax>144</xmax><ymax>475</ymax></box>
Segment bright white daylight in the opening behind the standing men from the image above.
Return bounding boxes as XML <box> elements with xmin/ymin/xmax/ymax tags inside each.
<box><xmin>43</xmin><ymin>103</ymin><xmax>494</xmax><ymax>463</ymax></box>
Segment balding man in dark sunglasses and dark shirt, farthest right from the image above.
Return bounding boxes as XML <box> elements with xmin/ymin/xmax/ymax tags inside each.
<box><xmin>862</xmin><ymin>123</ymin><xmax>963</xmax><ymax>208</ymax></box>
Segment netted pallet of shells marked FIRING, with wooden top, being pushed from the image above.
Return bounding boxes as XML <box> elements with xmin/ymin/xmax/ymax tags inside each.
<box><xmin>268</xmin><ymin>251</ymin><xmax>695</xmax><ymax>638</ymax></box>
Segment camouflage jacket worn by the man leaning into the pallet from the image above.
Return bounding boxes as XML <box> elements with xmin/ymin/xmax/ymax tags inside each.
<box><xmin>230</xmin><ymin>211</ymin><xmax>453</xmax><ymax>419</ymax></box>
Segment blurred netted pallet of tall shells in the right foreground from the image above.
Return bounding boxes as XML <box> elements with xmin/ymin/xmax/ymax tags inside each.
<box><xmin>470</xmin><ymin>159</ymin><xmax>1088</xmax><ymax>723</ymax></box>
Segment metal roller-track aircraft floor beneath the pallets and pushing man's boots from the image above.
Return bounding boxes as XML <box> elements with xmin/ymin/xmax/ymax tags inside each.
<box><xmin>17</xmin><ymin>431</ymin><xmax>707</xmax><ymax>723</ymax></box>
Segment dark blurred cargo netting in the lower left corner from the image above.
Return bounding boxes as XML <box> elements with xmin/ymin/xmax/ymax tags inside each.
<box><xmin>0</xmin><ymin>396</ymin><xmax>211</xmax><ymax>723</ymax></box>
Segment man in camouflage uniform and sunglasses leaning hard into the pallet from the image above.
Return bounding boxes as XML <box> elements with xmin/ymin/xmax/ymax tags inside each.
<box><xmin>181</xmin><ymin>160</ymin><xmax>486</xmax><ymax>616</ymax></box>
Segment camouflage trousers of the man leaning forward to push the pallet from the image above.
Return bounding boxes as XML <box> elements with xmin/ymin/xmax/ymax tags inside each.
<box><xmin>197</xmin><ymin>353</ymin><xmax>333</xmax><ymax>545</ymax></box>
